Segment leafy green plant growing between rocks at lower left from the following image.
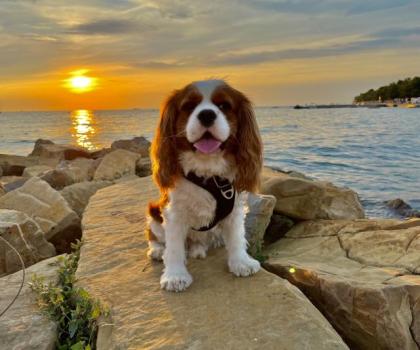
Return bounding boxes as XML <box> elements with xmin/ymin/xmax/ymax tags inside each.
<box><xmin>30</xmin><ymin>242</ymin><xmax>106</xmax><ymax>350</ymax></box>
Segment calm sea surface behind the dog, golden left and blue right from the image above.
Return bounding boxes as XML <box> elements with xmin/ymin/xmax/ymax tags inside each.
<box><xmin>0</xmin><ymin>108</ymin><xmax>420</xmax><ymax>217</ymax></box>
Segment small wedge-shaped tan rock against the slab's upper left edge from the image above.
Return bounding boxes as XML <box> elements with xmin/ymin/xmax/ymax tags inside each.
<box><xmin>60</xmin><ymin>181</ymin><xmax>112</xmax><ymax>217</ymax></box>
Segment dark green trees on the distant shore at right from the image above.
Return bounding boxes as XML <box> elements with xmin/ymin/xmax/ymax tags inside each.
<box><xmin>354</xmin><ymin>77</ymin><xmax>420</xmax><ymax>102</ymax></box>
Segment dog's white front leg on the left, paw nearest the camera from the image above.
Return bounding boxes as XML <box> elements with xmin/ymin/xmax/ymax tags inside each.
<box><xmin>160</xmin><ymin>219</ymin><xmax>192</xmax><ymax>292</ymax></box>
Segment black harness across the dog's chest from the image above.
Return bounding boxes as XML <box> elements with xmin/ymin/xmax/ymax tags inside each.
<box><xmin>185</xmin><ymin>172</ymin><xmax>235</xmax><ymax>231</ymax></box>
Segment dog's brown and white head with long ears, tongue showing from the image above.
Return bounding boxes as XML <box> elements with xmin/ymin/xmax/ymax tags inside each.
<box><xmin>151</xmin><ymin>80</ymin><xmax>262</xmax><ymax>191</ymax></box>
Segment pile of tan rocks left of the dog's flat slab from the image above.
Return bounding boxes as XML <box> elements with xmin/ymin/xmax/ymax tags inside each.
<box><xmin>0</xmin><ymin>137</ymin><xmax>150</xmax><ymax>349</ymax></box>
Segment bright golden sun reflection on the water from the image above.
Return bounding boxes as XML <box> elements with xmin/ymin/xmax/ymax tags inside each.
<box><xmin>71</xmin><ymin>109</ymin><xmax>96</xmax><ymax>150</ymax></box>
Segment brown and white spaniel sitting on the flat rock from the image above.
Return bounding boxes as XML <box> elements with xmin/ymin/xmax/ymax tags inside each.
<box><xmin>148</xmin><ymin>80</ymin><xmax>262</xmax><ymax>292</ymax></box>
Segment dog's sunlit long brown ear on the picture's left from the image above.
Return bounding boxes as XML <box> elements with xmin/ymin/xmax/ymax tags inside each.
<box><xmin>151</xmin><ymin>91</ymin><xmax>181</xmax><ymax>192</ymax></box>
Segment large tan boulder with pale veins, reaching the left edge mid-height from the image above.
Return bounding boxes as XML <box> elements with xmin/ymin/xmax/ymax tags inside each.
<box><xmin>0</xmin><ymin>177</ymin><xmax>80</xmax><ymax>254</ymax></box>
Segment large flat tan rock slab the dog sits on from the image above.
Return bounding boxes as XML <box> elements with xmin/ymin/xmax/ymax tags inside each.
<box><xmin>77</xmin><ymin>177</ymin><xmax>347</xmax><ymax>350</ymax></box>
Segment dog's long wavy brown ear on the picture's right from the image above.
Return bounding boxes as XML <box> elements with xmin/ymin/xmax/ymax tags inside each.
<box><xmin>235</xmin><ymin>91</ymin><xmax>263</xmax><ymax>192</ymax></box>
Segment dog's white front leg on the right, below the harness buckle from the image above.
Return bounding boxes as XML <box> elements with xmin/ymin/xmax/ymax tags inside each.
<box><xmin>223</xmin><ymin>196</ymin><xmax>260</xmax><ymax>277</ymax></box>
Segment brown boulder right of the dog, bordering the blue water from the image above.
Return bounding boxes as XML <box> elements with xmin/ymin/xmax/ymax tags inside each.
<box><xmin>261</xmin><ymin>168</ymin><xmax>364</xmax><ymax>220</ymax></box>
